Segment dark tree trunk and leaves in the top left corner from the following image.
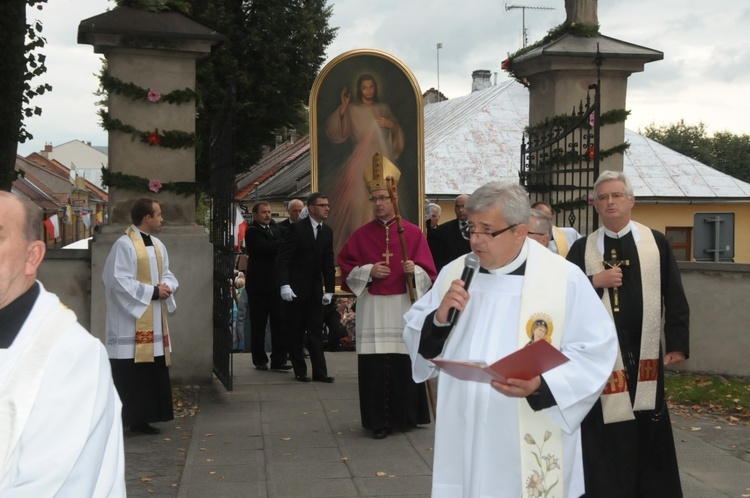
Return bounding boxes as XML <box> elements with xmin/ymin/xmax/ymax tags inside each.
<box><xmin>0</xmin><ymin>0</ymin><xmax>52</xmax><ymax>191</ymax></box>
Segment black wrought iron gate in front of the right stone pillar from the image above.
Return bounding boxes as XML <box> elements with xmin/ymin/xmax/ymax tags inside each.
<box><xmin>519</xmin><ymin>83</ymin><xmax>601</xmax><ymax>234</ymax></box>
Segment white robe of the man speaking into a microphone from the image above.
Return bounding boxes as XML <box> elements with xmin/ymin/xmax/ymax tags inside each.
<box><xmin>404</xmin><ymin>242</ymin><xmax>617</xmax><ymax>498</ymax></box>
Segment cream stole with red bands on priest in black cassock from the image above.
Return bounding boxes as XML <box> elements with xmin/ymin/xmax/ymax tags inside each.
<box><xmin>585</xmin><ymin>221</ymin><xmax>661</xmax><ymax>424</ymax></box>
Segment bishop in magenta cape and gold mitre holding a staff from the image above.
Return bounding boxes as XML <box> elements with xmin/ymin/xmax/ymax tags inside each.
<box><xmin>339</xmin><ymin>158</ymin><xmax>436</xmax><ymax>439</ymax></box>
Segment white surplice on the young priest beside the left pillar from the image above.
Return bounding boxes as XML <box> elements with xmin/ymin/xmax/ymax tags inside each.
<box><xmin>102</xmin><ymin>227</ymin><xmax>179</xmax><ymax>360</ymax></box>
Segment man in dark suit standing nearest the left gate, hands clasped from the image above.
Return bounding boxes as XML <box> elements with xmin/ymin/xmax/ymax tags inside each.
<box><xmin>245</xmin><ymin>201</ymin><xmax>292</xmax><ymax>370</ymax></box>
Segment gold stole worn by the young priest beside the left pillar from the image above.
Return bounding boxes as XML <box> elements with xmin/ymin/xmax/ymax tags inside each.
<box><xmin>125</xmin><ymin>227</ymin><xmax>171</xmax><ymax>365</ymax></box>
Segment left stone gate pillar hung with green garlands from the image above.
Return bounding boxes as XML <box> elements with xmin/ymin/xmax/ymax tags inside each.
<box><xmin>78</xmin><ymin>7</ymin><xmax>224</xmax><ymax>383</ymax></box>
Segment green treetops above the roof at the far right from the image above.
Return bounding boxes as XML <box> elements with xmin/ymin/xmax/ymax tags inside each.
<box><xmin>641</xmin><ymin>120</ymin><xmax>750</xmax><ymax>183</ymax></box>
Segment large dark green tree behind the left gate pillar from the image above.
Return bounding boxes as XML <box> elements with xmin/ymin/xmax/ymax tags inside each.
<box><xmin>189</xmin><ymin>0</ymin><xmax>336</xmax><ymax>181</ymax></box>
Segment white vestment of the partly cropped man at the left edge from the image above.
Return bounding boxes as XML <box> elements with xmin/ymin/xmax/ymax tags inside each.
<box><xmin>0</xmin><ymin>283</ymin><xmax>125</xmax><ymax>498</ymax></box>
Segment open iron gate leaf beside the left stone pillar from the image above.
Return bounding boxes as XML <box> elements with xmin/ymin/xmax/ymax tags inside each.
<box><xmin>209</xmin><ymin>91</ymin><xmax>235</xmax><ymax>391</ymax></box>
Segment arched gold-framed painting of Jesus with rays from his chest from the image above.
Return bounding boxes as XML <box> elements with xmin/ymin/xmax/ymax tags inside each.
<box><xmin>310</xmin><ymin>49</ymin><xmax>424</xmax><ymax>256</ymax></box>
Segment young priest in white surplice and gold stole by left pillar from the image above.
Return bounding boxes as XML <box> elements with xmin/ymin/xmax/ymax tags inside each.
<box><xmin>102</xmin><ymin>198</ymin><xmax>178</xmax><ymax>434</ymax></box>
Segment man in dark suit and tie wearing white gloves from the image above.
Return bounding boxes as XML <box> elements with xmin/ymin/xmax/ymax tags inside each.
<box><xmin>277</xmin><ymin>192</ymin><xmax>336</xmax><ymax>383</ymax></box>
